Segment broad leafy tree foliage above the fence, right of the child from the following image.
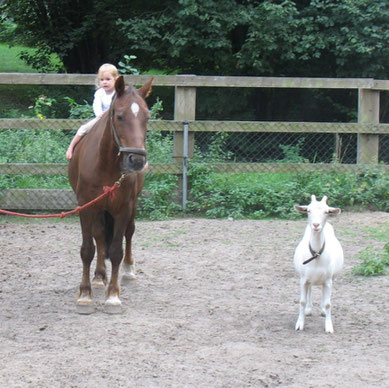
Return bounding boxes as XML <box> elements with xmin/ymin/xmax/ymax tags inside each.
<box><xmin>113</xmin><ymin>0</ymin><xmax>389</xmax><ymax>78</ymax></box>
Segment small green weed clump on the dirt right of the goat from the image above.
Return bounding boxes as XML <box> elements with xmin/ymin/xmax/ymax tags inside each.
<box><xmin>353</xmin><ymin>246</ymin><xmax>389</xmax><ymax>276</ymax></box>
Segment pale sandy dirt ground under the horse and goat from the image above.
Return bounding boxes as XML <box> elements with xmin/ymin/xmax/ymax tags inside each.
<box><xmin>0</xmin><ymin>212</ymin><xmax>389</xmax><ymax>388</ymax></box>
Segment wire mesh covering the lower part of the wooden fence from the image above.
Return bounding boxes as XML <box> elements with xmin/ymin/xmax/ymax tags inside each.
<box><xmin>0</xmin><ymin>119</ymin><xmax>389</xmax><ymax>210</ymax></box>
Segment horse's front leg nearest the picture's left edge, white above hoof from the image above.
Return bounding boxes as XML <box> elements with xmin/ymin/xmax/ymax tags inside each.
<box><xmin>76</xmin><ymin>215</ymin><xmax>95</xmax><ymax>314</ymax></box>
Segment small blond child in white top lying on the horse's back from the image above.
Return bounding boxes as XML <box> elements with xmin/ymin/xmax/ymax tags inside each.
<box><xmin>66</xmin><ymin>63</ymin><xmax>119</xmax><ymax>159</ymax></box>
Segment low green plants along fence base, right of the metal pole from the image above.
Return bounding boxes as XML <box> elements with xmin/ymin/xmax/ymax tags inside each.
<box><xmin>189</xmin><ymin>162</ymin><xmax>389</xmax><ymax>218</ymax></box>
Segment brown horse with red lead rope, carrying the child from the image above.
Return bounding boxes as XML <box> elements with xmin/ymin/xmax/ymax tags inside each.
<box><xmin>68</xmin><ymin>76</ymin><xmax>153</xmax><ymax>314</ymax></box>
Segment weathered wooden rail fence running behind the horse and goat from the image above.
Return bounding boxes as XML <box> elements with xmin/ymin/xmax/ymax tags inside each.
<box><xmin>0</xmin><ymin>73</ymin><xmax>389</xmax><ymax>210</ymax></box>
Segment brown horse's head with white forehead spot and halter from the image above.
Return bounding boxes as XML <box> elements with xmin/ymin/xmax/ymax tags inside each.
<box><xmin>110</xmin><ymin>76</ymin><xmax>153</xmax><ymax>172</ymax></box>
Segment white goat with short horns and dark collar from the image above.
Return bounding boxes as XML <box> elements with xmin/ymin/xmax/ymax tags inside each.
<box><xmin>294</xmin><ymin>195</ymin><xmax>343</xmax><ymax>333</ymax></box>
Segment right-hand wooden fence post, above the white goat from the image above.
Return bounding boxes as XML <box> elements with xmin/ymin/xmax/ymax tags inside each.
<box><xmin>357</xmin><ymin>89</ymin><xmax>380</xmax><ymax>164</ymax></box>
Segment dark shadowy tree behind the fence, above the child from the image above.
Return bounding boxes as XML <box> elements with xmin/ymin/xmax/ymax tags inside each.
<box><xmin>2</xmin><ymin>0</ymin><xmax>130</xmax><ymax>73</ymax></box>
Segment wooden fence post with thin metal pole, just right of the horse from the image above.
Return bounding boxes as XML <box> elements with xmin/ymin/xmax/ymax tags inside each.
<box><xmin>173</xmin><ymin>77</ymin><xmax>196</xmax><ymax>210</ymax></box>
